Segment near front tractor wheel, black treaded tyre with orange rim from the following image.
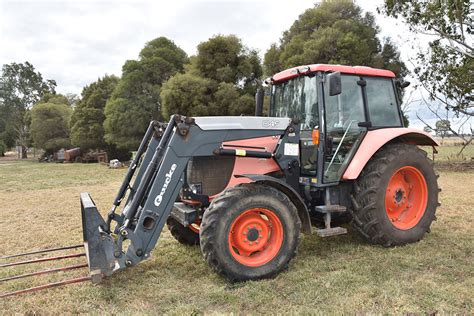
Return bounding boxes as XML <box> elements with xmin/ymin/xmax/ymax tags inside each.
<box><xmin>200</xmin><ymin>183</ymin><xmax>301</xmax><ymax>282</ymax></box>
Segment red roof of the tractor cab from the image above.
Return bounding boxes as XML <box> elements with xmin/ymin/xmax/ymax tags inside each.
<box><xmin>272</xmin><ymin>64</ymin><xmax>395</xmax><ymax>83</ymax></box>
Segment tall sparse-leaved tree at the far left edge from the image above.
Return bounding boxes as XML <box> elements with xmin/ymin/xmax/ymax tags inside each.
<box><xmin>0</xmin><ymin>62</ymin><xmax>56</xmax><ymax>158</ymax></box>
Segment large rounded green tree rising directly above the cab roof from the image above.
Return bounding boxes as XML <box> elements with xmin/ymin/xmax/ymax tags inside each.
<box><xmin>264</xmin><ymin>0</ymin><xmax>407</xmax><ymax>77</ymax></box>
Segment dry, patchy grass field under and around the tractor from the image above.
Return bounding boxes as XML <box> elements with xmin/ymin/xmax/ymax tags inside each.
<box><xmin>0</xmin><ymin>157</ymin><xmax>474</xmax><ymax>314</ymax></box>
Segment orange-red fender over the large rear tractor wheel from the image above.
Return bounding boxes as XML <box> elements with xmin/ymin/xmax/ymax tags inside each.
<box><xmin>342</xmin><ymin>127</ymin><xmax>439</xmax><ymax>180</ymax></box>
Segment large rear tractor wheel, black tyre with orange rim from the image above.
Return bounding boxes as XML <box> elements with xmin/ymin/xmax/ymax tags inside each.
<box><xmin>352</xmin><ymin>143</ymin><xmax>441</xmax><ymax>247</ymax></box>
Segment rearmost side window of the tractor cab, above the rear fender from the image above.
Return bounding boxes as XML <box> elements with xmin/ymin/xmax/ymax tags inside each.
<box><xmin>364</xmin><ymin>77</ymin><xmax>402</xmax><ymax>127</ymax></box>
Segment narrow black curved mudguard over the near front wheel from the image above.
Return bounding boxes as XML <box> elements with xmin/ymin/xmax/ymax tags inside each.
<box><xmin>238</xmin><ymin>174</ymin><xmax>311</xmax><ymax>235</ymax></box>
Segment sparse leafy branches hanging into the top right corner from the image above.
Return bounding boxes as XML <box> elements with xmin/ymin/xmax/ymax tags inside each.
<box><xmin>379</xmin><ymin>0</ymin><xmax>474</xmax><ymax>117</ymax></box>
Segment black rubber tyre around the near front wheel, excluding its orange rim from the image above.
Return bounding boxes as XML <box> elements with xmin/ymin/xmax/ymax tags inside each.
<box><xmin>200</xmin><ymin>183</ymin><xmax>301</xmax><ymax>281</ymax></box>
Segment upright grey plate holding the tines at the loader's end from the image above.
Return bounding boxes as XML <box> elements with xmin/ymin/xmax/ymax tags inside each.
<box><xmin>81</xmin><ymin>193</ymin><xmax>115</xmax><ymax>283</ymax></box>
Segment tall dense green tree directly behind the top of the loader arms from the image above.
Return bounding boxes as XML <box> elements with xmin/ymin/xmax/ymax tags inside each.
<box><xmin>104</xmin><ymin>37</ymin><xmax>188</xmax><ymax>150</ymax></box>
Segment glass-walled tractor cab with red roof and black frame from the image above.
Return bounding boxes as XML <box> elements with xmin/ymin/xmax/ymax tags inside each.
<box><xmin>270</xmin><ymin>64</ymin><xmax>403</xmax><ymax>185</ymax></box>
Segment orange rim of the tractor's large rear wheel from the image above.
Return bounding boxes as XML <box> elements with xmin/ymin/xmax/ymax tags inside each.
<box><xmin>385</xmin><ymin>166</ymin><xmax>428</xmax><ymax>230</ymax></box>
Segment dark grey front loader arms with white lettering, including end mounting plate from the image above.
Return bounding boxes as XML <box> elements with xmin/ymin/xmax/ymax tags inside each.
<box><xmin>81</xmin><ymin>115</ymin><xmax>299</xmax><ymax>283</ymax></box>
